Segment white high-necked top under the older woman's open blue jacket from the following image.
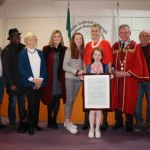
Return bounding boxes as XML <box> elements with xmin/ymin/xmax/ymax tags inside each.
<box><xmin>27</xmin><ymin>48</ymin><xmax>41</xmax><ymax>81</ymax></box>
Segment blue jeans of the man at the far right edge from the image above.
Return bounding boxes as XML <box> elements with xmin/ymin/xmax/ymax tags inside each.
<box><xmin>135</xmin><ymin>81</ymin><xmax>150</xmax><ymax>127</ymax></box>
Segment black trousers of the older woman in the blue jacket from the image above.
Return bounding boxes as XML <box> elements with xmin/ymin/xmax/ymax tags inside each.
<box><xmin>23</xmin><ymin>87</ymin><xmax>43</xmax><ymax>128</ymax></box>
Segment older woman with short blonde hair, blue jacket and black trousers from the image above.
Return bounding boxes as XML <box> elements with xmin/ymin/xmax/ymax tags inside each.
<box><xmin>19</xmin><ymin>32</ymin><xmax>47</xmax><ymax>135</ymax></box>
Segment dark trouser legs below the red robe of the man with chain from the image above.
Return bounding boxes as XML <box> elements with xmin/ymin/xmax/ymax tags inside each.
<box><xmin>115</xmin><ymin>109</ymin><xmax>133</xmax><ymax>128</ymax></box>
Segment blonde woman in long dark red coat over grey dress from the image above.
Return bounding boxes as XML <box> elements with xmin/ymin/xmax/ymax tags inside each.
<box><xmin>42</xmin><ymin>30</ymin><xmax>67</xmax><ymax>129</ymax></box>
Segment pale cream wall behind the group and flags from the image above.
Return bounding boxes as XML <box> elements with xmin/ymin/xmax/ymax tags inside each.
<box><xmin>0</xmin><ymin>0</ymin><xmax>150</xmax><ymax>49</ymax></box>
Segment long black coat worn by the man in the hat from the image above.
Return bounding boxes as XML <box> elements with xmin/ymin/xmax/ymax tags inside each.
<box><xmin>2</xmin><ymin>43</ymin><xmax>25</xmax><ymax>95</ymax></box>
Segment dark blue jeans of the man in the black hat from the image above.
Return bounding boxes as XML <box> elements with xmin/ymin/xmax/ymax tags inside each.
<box><xmin>8</xmin><ymin>95</ymin><xmax>27</xmax><ymax>125</ymax></box>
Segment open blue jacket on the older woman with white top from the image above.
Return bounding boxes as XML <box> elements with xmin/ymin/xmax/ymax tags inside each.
<box><xmin>19</xmin><ymin>49</ymin><xmax>48</xmax><ymax>87</ymax></box>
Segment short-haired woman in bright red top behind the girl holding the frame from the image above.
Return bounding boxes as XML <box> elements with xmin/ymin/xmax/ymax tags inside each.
<box><xmin>82</xmin><ymin>23</ymin><xmax>112</xmax><ymax>131</ymax></box>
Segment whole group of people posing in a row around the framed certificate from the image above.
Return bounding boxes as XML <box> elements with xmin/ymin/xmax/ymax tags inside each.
<box><xmin>1</xmin><ymin>24</ymin><xmax>150</xmax><ymax>138</ymax></box>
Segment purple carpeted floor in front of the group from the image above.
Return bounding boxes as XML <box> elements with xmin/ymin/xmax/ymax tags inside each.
<box><xmin>0</xmin><ymin>118</ymin><xmax>150</xmax><ymax>150</ymax></box>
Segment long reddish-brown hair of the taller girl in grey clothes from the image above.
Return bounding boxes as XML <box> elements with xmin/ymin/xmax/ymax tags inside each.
<box><xmin>70</xmin><ymin>32</ymin><xmax>84</xmax><ymax>59</ymax></box>
